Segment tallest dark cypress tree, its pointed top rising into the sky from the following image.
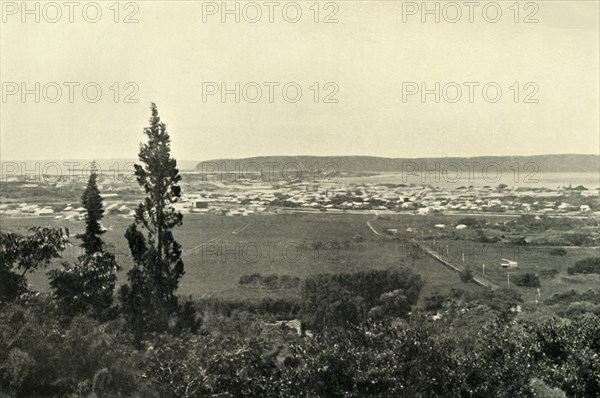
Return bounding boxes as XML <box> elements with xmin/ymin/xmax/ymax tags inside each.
<box><xmin>121</xmin><ymin>103</ymin><xmax>184</xmax><ymax>330</ymax></box>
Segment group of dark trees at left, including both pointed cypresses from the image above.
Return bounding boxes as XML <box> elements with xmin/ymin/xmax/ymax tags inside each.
<box><xmin>0</xmin><ymin>104</ymin><xmax>197</xmax><ymax>341</ymax></box>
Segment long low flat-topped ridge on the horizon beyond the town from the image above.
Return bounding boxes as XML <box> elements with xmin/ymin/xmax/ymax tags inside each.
<box><xmin>196</xmin><ymin>154</ymin><xmax>600</xmax><ymax>174</ymax></box>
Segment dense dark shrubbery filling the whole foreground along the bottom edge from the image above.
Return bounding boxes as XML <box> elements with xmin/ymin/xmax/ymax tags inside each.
<box><xmin>0</xmin><ymin>293</ymin><xmax>600</xmax><ymax>398</ymax></box>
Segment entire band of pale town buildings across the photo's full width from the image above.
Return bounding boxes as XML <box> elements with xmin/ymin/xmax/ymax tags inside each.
<box><xmin>0</xmin><ymin>181</ymin><xmax>600</xmax><ymax>220</ymax></box>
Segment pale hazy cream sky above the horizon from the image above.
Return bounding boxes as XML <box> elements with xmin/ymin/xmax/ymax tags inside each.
<box><xmin>0</xmin><ymin>1</ymin><xmax>600</xmax><ymax>160</ymax></box>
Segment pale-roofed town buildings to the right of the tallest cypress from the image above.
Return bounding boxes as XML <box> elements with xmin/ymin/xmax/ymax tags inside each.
<box><xmin>180</xmin><ymin>182</ymin><xmax>598</xmax><ymax>215</ymax></box>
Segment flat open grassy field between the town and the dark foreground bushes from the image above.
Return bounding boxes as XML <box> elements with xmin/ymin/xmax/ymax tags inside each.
<box><xmin>2</xmin><ymin>213</ymin><xmax>600</xmax><ymax>301</ymax></box>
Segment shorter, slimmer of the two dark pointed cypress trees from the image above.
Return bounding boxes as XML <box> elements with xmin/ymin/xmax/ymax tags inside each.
<box><xmin>76</xmin><ymin>162</ymin><xmax>105</xmax><ymax>255</ymax></box>
